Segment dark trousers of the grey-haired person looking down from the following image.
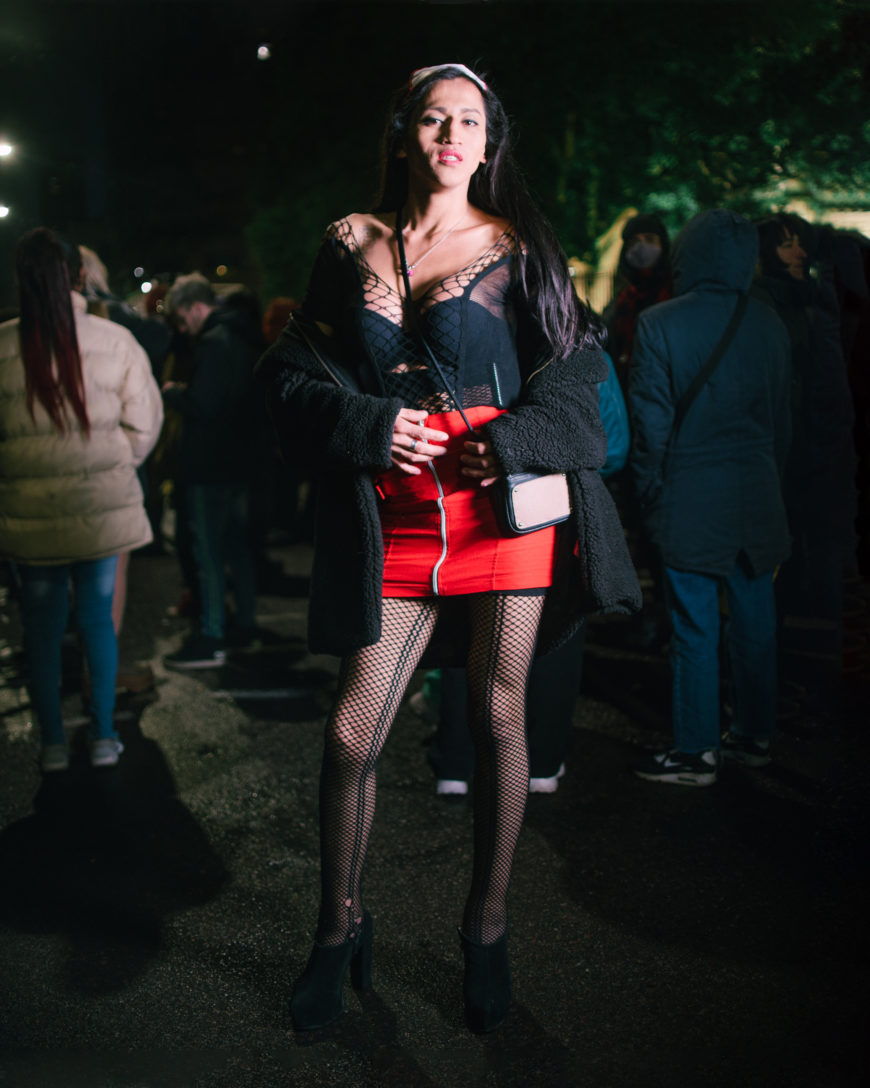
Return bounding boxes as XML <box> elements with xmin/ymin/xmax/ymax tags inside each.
<box><xmin>187</xmin><ymin>483</ymin><xmax>254</xmax><ymax>640</ymax></box>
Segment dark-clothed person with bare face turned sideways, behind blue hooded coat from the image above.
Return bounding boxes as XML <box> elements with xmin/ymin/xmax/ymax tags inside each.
<box><xmin>753</xmin><ymin>213</ymin><xmax>857</xmax><ymax>695</ymax></box>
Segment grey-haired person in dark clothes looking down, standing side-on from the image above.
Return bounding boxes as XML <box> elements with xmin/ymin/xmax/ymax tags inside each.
<box><xmin>163</xmin><ymin>272</ymin><xmax>263</xmax><ymax>669</ymax></box>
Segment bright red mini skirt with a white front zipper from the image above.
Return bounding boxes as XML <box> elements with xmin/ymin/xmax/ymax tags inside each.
<box><xmin>375</xmin><ymin>407</ymin><xmax>557</xmax><ymax>597</ymax></box>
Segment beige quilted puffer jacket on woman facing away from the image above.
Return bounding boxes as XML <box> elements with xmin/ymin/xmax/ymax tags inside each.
<box><xmin>0</xmin><ymin>292</ymin><xmax>163</xmax><ymax>565</ymax></box>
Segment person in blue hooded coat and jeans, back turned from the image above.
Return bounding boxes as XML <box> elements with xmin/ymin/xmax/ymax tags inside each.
<box><xmin>630</xmin><ymin>209</ymin><xmax>791</xmax><ymax>786</ymax></box>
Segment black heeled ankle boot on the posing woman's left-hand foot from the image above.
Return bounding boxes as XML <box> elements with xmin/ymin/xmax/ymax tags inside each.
<box><xmin>290</xmin><ymin>911</ymin><xmax>373</xmax><ymax>1031</ymax></box>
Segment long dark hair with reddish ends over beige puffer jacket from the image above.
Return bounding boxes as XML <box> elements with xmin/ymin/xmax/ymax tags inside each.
<box><xmin>15</xmin><ymin>226</ymin><xmax>90</xmax><ymax>435</ymax></box>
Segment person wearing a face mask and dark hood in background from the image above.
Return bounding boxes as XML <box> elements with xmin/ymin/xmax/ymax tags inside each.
<box><xmin>605</xmin><ymin>215</ymin><xmax>673</xmax><ymax>392</ymax></box>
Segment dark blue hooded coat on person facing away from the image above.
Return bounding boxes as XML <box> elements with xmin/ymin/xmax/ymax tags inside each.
<box><xmin>630</xmin><ymin>210</ymin><xmax>791</xmax><ymax>574</ymax></box>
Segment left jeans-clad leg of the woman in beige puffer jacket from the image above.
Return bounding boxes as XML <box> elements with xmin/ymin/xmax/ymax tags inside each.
<box><xmin>18</xmin><ymin>564</ymin><xmax>70</xmax><ymax>744</ymax></box>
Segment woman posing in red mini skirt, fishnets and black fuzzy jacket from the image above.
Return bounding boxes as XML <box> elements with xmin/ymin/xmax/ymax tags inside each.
<box><xmin>263</xmin><ymin>64</ymin><xmax>639</xmax><ymax>1030</ymax></box>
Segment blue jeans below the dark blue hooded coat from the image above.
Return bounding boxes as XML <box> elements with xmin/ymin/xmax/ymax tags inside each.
<box><xmin>664</xmin><ymin>561</ymin><xmax>776</xmax><ymax>753</ymax></box>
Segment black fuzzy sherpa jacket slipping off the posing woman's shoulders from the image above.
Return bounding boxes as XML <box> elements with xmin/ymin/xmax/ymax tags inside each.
<box><xmin>258</xmin><ymin>321</ymin><xmax>641</xmax><ymax>665</ymax></box>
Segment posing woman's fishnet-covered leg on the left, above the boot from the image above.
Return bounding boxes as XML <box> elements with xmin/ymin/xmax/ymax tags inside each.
<box><xmin>316</xmin><ymin>598</ymin><xmax>437</xmax><ymax>947</ymax></box>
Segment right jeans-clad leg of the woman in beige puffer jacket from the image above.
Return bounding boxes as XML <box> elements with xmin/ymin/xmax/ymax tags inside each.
<box><xmin>72</xmin><ymin>555</ymin><xmax>117</xmax><ymax>740</ymax></box>
